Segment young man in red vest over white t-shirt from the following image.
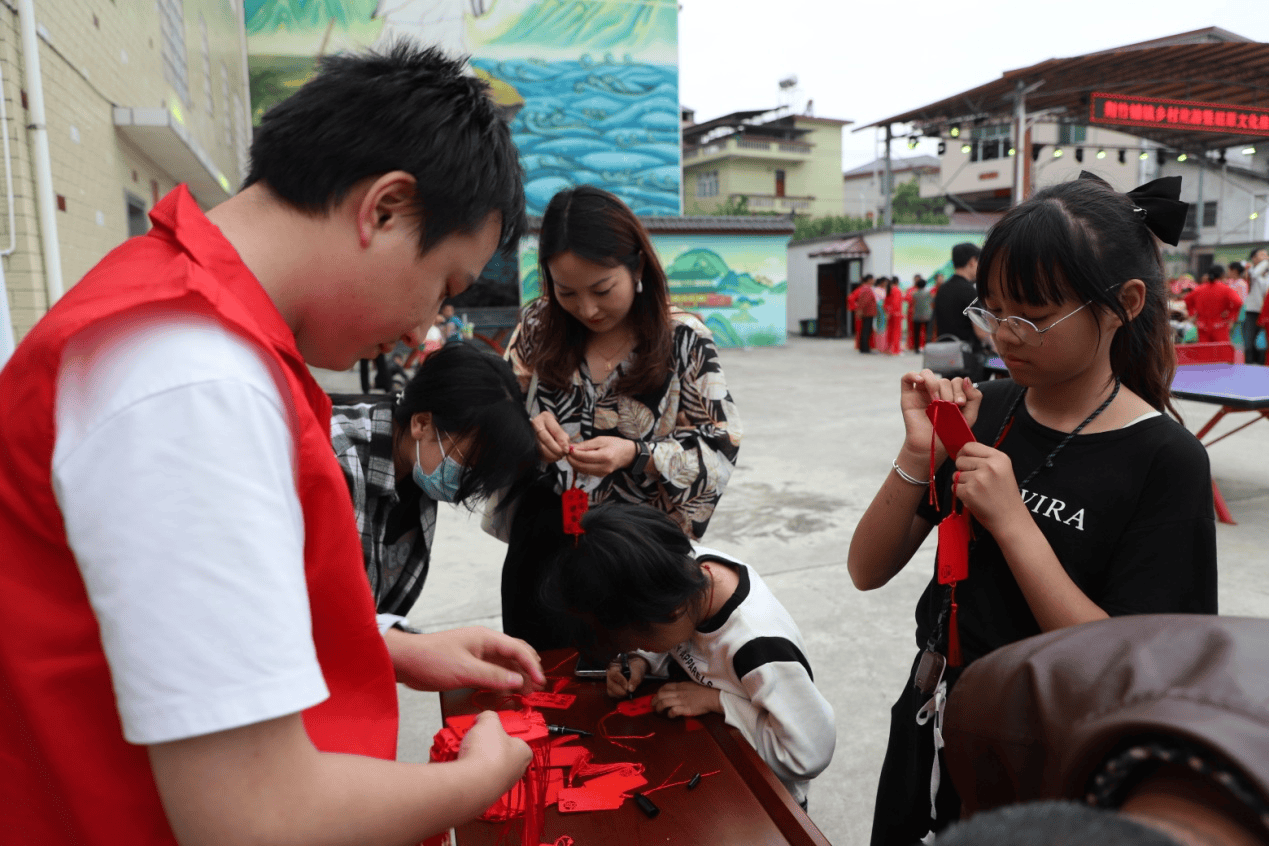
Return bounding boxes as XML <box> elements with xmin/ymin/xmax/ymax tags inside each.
<box><xmin>0</xmin><ymin>47</ymin><xmax>544</xmax><ymax>845</ymax></box>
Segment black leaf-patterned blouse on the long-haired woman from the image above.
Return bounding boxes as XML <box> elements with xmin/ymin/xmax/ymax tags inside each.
<box><xmin>508</xmin><ymin>301</ymin><xmax>741</xmax><ymax>539</ymax></box>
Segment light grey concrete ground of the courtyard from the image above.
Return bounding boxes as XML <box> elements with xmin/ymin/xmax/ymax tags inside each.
<box><xmin>309</xmin><ymin>337</ymin><xmax>1269</xmax><ymax>846</ymax></box>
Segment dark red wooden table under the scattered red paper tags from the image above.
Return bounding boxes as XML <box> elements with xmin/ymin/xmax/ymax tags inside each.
<box><xmin>440</xmin><ymin>651</ymin><xmax>829</xmax><ymax>846</ymax></box>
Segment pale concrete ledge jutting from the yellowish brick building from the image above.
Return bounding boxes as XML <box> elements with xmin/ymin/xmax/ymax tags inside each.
<box><xmin>114</xmin><ymin>107</ymin><xmax>235</xmax><ymax>208</ymax></box>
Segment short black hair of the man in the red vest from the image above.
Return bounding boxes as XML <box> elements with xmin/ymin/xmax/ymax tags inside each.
<box><xmin>242</xmin><ymin>41</ymin><xmax>525</xmax><ymax>254</ymax></box>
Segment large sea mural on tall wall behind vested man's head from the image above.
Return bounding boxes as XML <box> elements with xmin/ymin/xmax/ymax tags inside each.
<box><xmin>245</xmin><ymin>0</ymin><xmax>681</xmax><ymax>214</ymax></box>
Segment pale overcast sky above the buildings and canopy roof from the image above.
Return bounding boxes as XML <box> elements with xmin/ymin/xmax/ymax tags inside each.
<box><xmin>679</xmin><ymin>0</ymin><xmax>1269</xmax><ymax>169</ymax></box>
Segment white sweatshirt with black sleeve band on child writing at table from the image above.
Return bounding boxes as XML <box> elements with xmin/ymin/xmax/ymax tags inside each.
<box><xmin>640</xmin><ymin>547</ymin><xmax>838</xmax><ymax>803</ymax></box>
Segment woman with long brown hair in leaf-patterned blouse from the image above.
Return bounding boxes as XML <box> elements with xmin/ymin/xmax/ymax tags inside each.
<box><xmin>503</xmin><ymin>185</ymin><xmax>741</xmax><ymax>649</ymax></box>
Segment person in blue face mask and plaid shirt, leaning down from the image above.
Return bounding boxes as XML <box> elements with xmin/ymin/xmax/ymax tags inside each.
<box><xmin>330</xmin><ymin>344</ymin><xmax>537</xmax><ymax>628</ymax></box>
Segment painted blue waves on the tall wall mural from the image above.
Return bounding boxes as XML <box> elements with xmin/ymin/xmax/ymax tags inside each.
<box><xmin>472</xmin><ymin>55</ymin><xmax>680</xmax><ymax>214</ymax></box>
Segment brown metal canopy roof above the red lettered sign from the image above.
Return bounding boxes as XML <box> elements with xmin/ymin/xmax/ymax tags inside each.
<box><xmin>860</xmin><ymin>27</ymin><xmax>1269</xmax><ymax>151</ymax></box>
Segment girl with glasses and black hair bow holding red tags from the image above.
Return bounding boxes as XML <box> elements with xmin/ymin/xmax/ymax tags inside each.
<box><xmin>849</xmin><ymin>175</ymin><xmax>1216</xmax><ymax>843</ymax></box>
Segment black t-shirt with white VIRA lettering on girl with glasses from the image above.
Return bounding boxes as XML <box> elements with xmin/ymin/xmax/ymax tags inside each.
<box><xmin>916</xmin><ymin>379</ymin><xmax>1216</xmax><ymax>662</ymax></box>
